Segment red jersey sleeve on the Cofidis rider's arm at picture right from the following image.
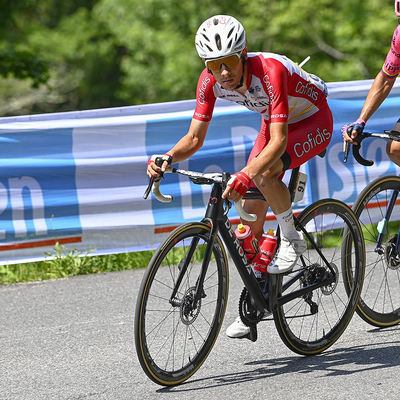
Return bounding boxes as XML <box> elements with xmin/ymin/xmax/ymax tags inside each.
<box><xmin>264</xmin><ymin>59</ymin><xmax>289</xmax><ymax>123</ymax></box>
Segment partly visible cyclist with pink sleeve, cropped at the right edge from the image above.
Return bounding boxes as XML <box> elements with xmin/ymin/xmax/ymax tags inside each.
<box><xmin>342</xmin><ymin>0</ymin><xmax>400</xmax><ymax>166</ymax></box>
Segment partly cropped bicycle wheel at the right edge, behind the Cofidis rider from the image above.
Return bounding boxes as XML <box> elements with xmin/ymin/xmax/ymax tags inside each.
<box><xmin>353</xmin><ymin>175</ymin><xmax>400</xmax><ymax>328</ymax></box>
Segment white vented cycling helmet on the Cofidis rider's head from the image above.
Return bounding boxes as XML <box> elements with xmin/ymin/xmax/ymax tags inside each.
<box><xmin>195</xmin><ymin>15</ymin><xmax>246</xmax><ymax>59</ymax></box>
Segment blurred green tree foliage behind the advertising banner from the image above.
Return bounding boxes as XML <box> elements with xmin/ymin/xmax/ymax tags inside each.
<box><xmin>0</xmin><ymin>0</ymin><xmax>397</xmax><ymax>115</ymax></box>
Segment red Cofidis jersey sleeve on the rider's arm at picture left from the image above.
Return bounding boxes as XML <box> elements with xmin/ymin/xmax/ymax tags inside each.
<box><xmin>193</xmin><ymin>69</ymin><xmax>217</xmax><ymax>122</ymax></box>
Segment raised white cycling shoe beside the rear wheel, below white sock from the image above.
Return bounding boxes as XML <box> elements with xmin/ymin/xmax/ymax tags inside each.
<box><xmin>267</xmin><ymin>234</ymin><xmax>307</xmax><ymax>274</ymax></box>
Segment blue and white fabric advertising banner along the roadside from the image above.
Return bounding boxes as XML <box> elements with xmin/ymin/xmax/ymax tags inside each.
<box><xmin>0</xmin><ymin>80</ymin><xmax>400</xmax><ymax>264</ymax></box>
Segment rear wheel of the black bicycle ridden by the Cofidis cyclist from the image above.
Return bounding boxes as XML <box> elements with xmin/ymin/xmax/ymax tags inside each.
<box><xmin>274</xmin><ymin>199</ymin><xmax>365</xmax><ymax>355</ymax></box>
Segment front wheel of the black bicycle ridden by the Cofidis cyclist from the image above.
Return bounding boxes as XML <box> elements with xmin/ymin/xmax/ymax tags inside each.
<box><xmin>134</xmin><ymin>222</ymin><xmax>229</xmax><ymax>386</ymax></box>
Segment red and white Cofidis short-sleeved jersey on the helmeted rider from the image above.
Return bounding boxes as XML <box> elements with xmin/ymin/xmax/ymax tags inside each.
<box><xmin>193</xmin><ymin>53</ymin><xmax>328</xmax><ymax>124</ymax></box>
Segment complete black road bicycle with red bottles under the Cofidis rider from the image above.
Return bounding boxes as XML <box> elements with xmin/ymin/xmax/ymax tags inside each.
<box><xmin>134</xmin><ymin>157</ymin><xmax>365</xmax><ymax>386</ymax></box>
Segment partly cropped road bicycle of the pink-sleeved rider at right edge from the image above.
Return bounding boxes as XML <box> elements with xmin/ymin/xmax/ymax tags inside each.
<box><xmin>344</xmin><ymin>130</ymin><xmax>400</xmax><ymax>328</ymax></box>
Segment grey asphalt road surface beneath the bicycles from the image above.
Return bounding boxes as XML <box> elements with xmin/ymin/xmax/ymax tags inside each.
<box><xmin>0</xmin><ymin>262</ymin><xmax>400</xmax><ymax>400</ymax></box>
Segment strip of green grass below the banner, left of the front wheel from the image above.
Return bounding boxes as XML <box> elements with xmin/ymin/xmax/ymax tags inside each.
<box><xmin>0</xmin><ymin>245</ymin><xmax>154</xmax><ymax>285</ymax></box>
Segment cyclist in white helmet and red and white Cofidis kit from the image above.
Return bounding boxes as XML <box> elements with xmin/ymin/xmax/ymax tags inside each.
<box><xmin>147</xmin><ymin>15</ymin><xmax>333</xmax><ymax>337</ymax></box>
